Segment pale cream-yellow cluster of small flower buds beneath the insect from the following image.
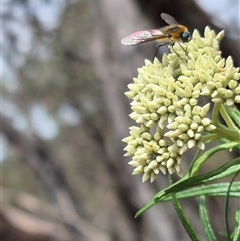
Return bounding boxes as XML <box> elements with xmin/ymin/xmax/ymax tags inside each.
<box><xmin>123</xmin><ymin>27</ymin><xmax>240</xmax><ymax>182</ymax></box>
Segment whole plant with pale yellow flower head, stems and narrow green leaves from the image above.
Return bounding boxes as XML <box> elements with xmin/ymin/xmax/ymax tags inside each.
<box><xmin>123</xmin><ymin>27</ymin><xmax>240</xmax><ymax>241</ymax></box>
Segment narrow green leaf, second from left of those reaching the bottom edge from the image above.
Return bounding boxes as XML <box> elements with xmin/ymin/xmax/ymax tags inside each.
<box><xmin>199</xmin><ymin>195</ymin><xmax>217</xmax><ymax>241</ymax></box>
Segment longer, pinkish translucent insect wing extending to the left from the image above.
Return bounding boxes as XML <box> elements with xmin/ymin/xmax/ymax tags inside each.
<box><xmin>121</xmin><ymin>29</ymin><xmax>164</xmax><ymax>45</ymax></box>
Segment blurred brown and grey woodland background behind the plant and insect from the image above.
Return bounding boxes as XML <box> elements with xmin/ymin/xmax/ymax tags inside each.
<box><xmin>0</xmin><ymin>0</ymin><xmax>240</xmax><ymax>241</ymax></box>
